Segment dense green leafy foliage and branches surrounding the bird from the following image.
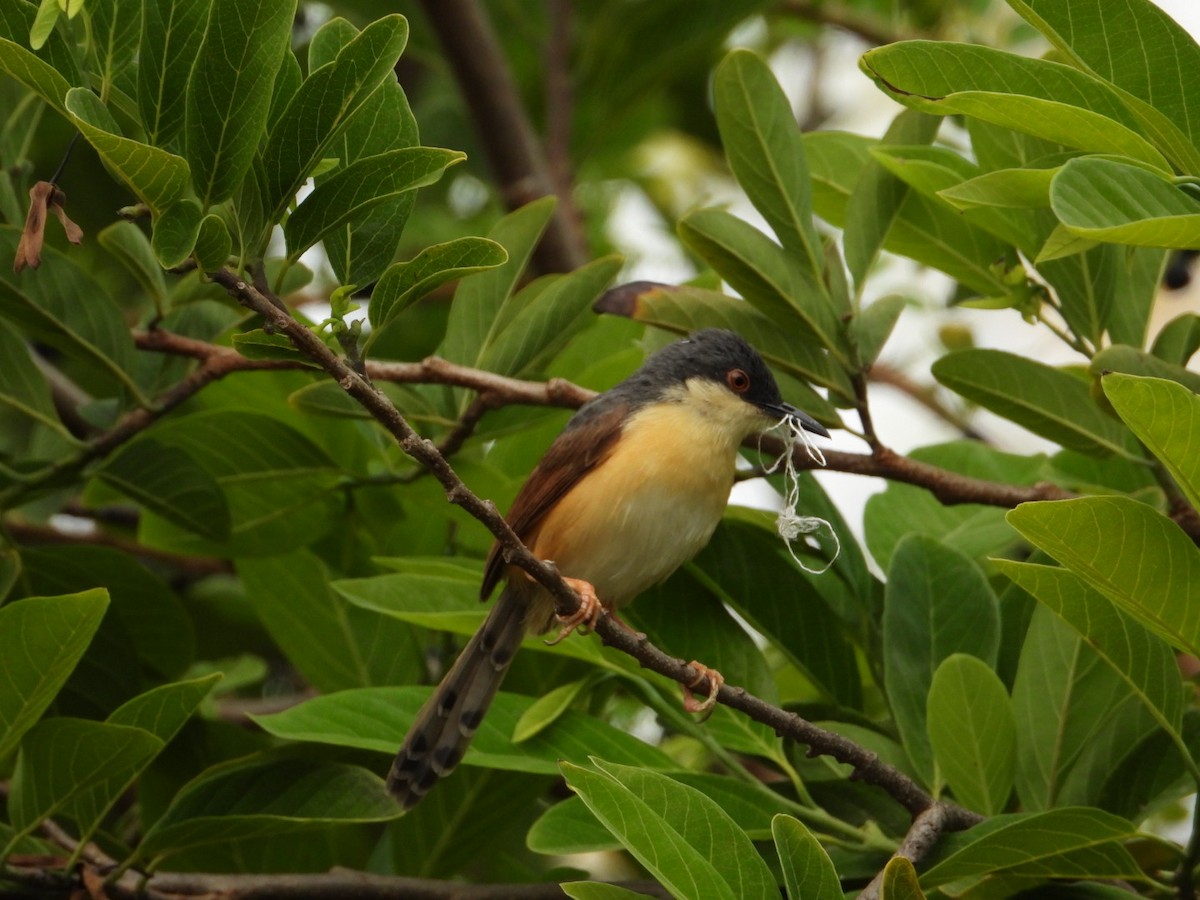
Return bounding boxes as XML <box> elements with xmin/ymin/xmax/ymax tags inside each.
<box><xmin>0</xmin><ymin>0</ymin><xmax>1200</xmax><ymax>899</ymax></box>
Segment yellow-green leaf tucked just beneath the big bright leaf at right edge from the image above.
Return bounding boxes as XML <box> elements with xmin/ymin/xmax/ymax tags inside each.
<box><xmin>992</xmin><ymin>559</ymin><xmax>1188</xmax><ymax>755</ymax></box>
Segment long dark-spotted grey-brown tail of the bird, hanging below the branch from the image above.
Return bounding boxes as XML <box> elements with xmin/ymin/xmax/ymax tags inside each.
<box><xmin>388</xmin><ymin>587</ymin><xmax>526</xmax><ymax>809</ymax></box>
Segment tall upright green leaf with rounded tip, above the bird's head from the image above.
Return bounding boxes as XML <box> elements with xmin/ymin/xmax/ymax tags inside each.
<box><xmin>713</xmin><ymin>49</ymin><xmax>828</xmax><ymax>285</ymax></box>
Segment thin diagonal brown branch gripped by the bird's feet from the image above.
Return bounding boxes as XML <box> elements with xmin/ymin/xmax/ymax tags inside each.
<box><xmin>212</xmin><ymin>270</ymin><xmax>980</xmax><ymax>828</ymax></box>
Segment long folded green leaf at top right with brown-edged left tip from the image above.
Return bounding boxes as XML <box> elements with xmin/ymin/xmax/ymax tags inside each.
<box><xmin>859</xmin><ymin>41</ymin><xmax>1169</xmax><ymax>172</ymax></box>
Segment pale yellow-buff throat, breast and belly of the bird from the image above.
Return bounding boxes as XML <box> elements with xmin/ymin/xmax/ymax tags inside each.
<box><xmin>530</xmin><ymin>383</ymin><xmax>764</xmax><ymax>607</ymax></box>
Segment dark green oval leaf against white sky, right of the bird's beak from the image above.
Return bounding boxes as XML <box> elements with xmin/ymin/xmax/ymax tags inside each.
<box><xmin>932</xmin><ymin>349</ymin><xmax>1132</xmax><ymax>456</ymax></box>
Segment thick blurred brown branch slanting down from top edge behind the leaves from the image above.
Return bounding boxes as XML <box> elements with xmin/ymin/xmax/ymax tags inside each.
<box><xmin>421</xmin><ymin>0</ymin><xmax>587</xmax><ymax>272</ymax></box>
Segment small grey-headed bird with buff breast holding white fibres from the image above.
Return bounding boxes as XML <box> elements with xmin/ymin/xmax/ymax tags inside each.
<box><xmin>386</xmin><ymin>329</ymin><xmax>829</xmax><ymax>809</ymax></box>
